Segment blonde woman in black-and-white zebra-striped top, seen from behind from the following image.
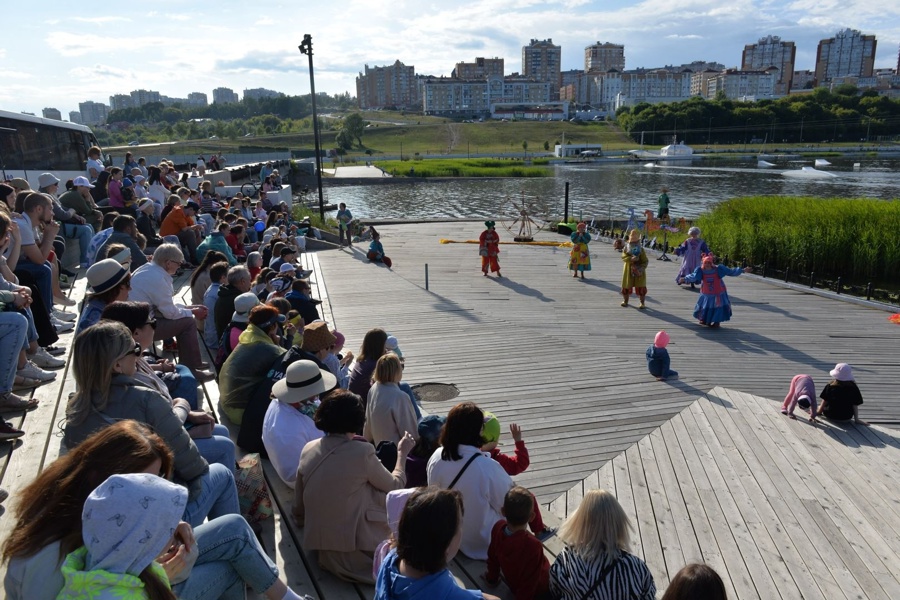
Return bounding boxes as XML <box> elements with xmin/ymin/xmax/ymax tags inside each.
<box><xmin>550</xmin><ymin>490</ymin><xmax>656</xmax><ymax>600</ymax></box>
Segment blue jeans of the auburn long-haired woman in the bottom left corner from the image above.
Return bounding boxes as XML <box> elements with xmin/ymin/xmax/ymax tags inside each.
<box><xmin>172</xmin><ymin>515</ymin><xmax>278</xmax><ymax>600</ymax></box>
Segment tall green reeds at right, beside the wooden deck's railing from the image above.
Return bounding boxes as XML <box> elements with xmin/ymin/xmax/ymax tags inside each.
<box><xmin>696</xmin><ymin>196</ymin><xmax>900</xmax><ymax>289</ymax></box>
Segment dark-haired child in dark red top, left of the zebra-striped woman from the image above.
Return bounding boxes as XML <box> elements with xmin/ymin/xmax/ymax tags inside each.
<box><xmin>483</xmin><ymin>486</ymin><xmax>550</xmax><ymax>600</ymax></box>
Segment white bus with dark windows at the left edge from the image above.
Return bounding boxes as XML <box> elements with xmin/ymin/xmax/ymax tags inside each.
<box><xmin>0</xmin><ymin>110</ymin><xmax>99</xmax><ymax>189</ymax></box>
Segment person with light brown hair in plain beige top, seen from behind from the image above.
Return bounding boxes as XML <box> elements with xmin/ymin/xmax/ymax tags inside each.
<box><xmin>363</xmin><ymin>352</ymin><xmax>419</xmax><ymax>445</ymax></box>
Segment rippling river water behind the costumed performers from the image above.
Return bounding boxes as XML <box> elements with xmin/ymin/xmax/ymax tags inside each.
<box><xmin>324</xmin><ymin>158</ymin><xmax>900</xmax><ymax>219</ymax></box>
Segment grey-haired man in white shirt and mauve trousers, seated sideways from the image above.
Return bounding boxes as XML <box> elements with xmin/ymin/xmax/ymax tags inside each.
<box><xmin>129</xmin><ymin>244</ymin><xmax>214</xmax><ymax>381</ymax></box>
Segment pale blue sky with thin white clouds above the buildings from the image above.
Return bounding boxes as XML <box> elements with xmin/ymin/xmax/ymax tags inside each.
<box><xmin>0</xmin><ymin>0</ymin><xmax>900</xmax><ymax>118</ymax></box>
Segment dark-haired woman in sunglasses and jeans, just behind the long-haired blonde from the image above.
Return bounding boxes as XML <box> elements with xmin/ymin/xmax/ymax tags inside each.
<box><xmin>103</xmin><ymin>302</ymin><xmax>235</xmax><ymax>470</ymax></box>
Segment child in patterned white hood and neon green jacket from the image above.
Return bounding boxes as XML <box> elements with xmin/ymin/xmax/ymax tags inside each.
<box><xmin>56</xmin><ymin>473</ymin><xmax>189</xmax><ymax>600</ymax></box>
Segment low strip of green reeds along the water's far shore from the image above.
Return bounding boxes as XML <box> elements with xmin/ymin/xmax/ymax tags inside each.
<box><xmin>375</xmin><ymin>158</ymin><xmax>553</xmax><ymax>177</ymax></box>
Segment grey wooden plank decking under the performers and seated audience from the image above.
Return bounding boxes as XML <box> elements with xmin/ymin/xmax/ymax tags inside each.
<box><xmin>0</xmin><ymin>223</ymin><xmax>900</xmax><ymax>599</ymax></box>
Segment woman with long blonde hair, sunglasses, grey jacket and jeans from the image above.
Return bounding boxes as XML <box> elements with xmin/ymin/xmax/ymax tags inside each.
<box><xmin>64</xmin><ymin>320</ymin><xmax>239</xmax><ymax>525</ymax></box>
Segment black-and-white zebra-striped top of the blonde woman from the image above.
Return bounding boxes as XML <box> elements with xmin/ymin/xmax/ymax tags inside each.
<box><xmin>550</xmin><ymin>547</ymin><xmax>656</xmax><ymax>600</ymax></box>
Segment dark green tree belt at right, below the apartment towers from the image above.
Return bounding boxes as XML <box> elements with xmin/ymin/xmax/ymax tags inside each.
<box><xmin>616</xmin><ymin>85</ymin><xmax>900</xmax><ymax>146</ymax></box>
